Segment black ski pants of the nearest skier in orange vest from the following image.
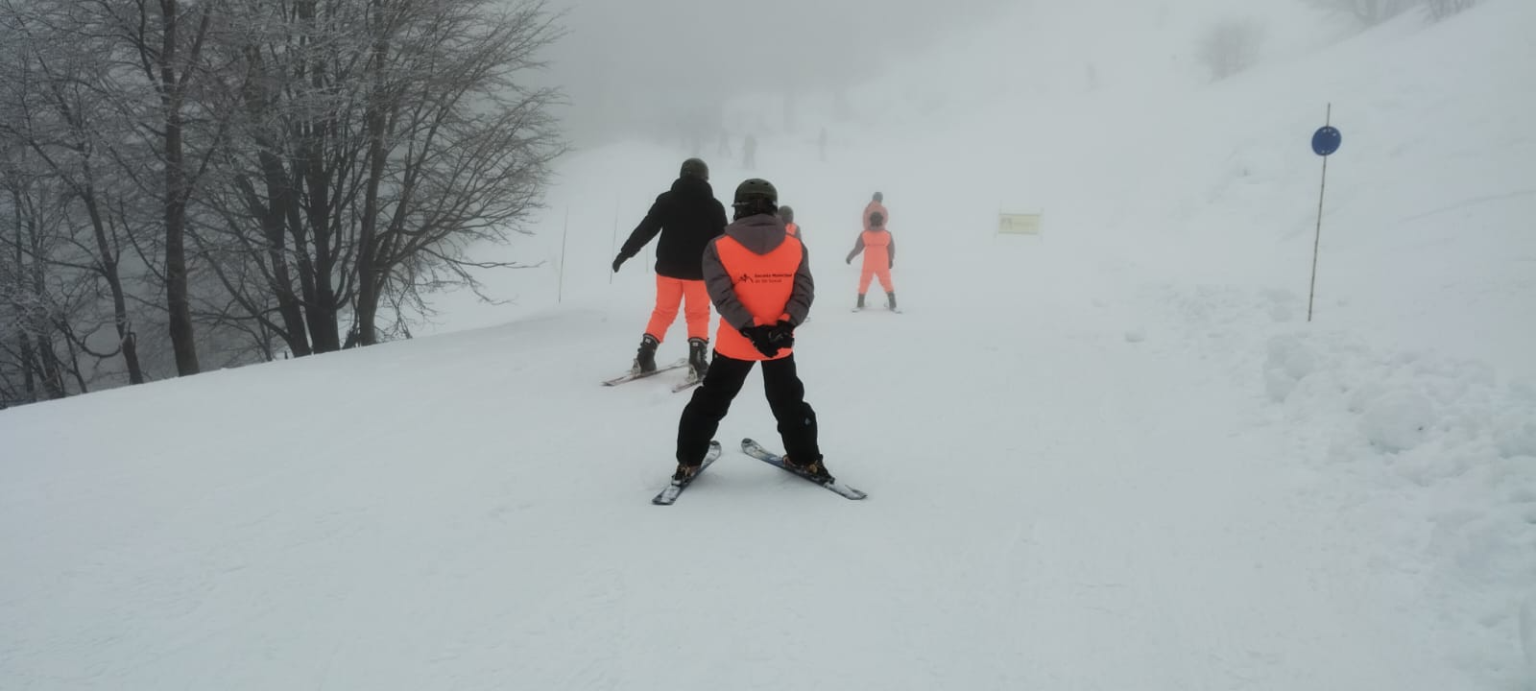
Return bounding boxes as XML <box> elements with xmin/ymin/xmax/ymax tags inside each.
<box><xmin>677</xmin><ymin>352</ymin><xmax>822</xmax><ymax>465</ymax></box>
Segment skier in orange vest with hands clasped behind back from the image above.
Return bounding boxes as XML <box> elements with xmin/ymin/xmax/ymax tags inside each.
<box><xmin>673</xmin><ymin>178</ymin><xmax>831</xmax><ymax>482</ymax></box>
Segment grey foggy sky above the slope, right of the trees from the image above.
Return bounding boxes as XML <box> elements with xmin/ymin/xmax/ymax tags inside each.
<box><xmin>534</xmin><ymin>0</ymin><xmax>1020</xmax><ymax>137</ymax></box>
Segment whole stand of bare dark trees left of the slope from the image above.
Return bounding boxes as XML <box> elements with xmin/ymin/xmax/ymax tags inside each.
<box><xmin>0</xmin><ymin>0</ymin><xmax>564</xmax><ymax>405</ymax></box>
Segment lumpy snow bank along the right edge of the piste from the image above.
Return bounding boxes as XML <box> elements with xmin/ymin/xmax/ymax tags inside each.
<box><xmin>1164</xmin><ymin>287</ymin><xmax>1536</xmax><ymax>689</ymax></box>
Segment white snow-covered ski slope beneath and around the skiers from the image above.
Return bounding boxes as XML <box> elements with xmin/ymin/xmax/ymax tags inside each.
<box><xmin>0</xmin><ymin>0</ymin><xmax>1536</xmax><ymax>691</ymax></box>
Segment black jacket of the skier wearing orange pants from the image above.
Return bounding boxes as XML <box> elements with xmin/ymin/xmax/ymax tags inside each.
<box><xmin>619</xmin><ymin>177</ymin><xmax>727</xmax><ymax>281</ymax></box>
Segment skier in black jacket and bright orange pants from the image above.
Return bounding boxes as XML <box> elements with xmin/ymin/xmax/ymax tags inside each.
<box><xmin>613</xmin><ymin>158</ymin><xmax>727</xmax><ymax>379</ymax></box>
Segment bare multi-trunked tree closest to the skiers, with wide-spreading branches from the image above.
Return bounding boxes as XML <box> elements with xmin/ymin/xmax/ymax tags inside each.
<box><xmin>200</xmin><ymin>0</ymin><xmax>562</xmax><ymax>348</ymax></box>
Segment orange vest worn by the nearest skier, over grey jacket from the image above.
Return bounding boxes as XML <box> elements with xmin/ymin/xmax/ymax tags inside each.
<box><xmin>714</xmin><ymin>235</ymin><xmax>805</xmax><ymax>361</ymax></box>
